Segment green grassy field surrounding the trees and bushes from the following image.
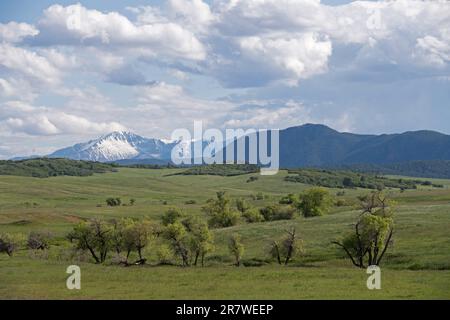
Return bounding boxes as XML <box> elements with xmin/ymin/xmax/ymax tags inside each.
<box><xmin>0</xmin><ymin>168</ymin><xmax>450</xmax><ymax>299</ymax></box>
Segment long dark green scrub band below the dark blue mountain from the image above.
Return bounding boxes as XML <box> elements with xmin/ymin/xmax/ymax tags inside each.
<box><xmin>285</xmin><ymin>169</ymin><xmax>423</xmax><ymax>190</ymax></box>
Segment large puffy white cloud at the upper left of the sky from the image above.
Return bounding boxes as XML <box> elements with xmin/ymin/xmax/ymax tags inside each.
<box><xmin>36</xmin><ymin>4</ymin><xmax>205</xmax><ymax>60</ymax></box>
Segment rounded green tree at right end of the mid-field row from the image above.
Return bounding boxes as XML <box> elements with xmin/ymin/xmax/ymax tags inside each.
<box><xmin>297</xmin><ymin>188</ymin><xmax>333</xmax><ymax>218</ymax></box>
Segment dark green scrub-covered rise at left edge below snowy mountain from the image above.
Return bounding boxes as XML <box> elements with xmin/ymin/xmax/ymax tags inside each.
<box><xmin>0</xmin><ymin>158</ymin><xmax>116</xmax><ymax>178</ymax></box>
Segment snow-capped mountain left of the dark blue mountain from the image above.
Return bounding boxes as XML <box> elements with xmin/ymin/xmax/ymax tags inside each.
<box><xmin>49</xmin><ymin>131</ymin><xmax>178</xmax><ymax>162</ymax></box>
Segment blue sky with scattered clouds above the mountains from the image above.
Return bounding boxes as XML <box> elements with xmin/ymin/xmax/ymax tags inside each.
<box><xmin>0</xmin><ymin>0</ymin><xmax>450</xmax><ymax>159</ymax></box>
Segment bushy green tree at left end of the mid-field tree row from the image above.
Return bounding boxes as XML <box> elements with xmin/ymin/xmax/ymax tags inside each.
<box><xmin>203</xmin><ymin>191</ymin><xmax>240</xmax><ymax>228</ymax></box>
